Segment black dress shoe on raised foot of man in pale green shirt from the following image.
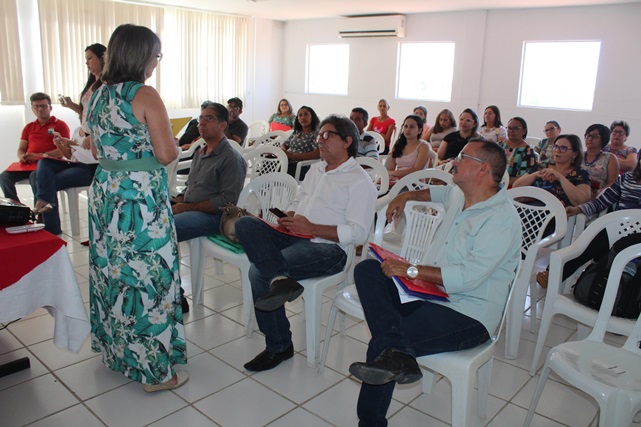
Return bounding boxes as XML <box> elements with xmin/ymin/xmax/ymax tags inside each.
<box><xmin>349</xmin><ymin>348</ymin><xmax>423</xmax><ymax>385</ymax></box>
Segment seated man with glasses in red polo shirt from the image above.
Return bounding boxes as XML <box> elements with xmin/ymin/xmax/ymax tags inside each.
<box><xmin>0</xmin><ymin>92</ymin><xmax>69</xmax><ymax>206</ymax></box>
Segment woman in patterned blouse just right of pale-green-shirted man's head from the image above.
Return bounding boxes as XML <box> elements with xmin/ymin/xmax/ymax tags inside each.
<box><xmin>499</xmin><ymin>117</ymin><xmax>538</xmax><ymax>187</ymax></box>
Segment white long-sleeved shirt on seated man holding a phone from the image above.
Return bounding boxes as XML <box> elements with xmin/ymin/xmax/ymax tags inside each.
<box><xmin>289</xmin><ymin>157</ymin><xmax>376</xmax><ymax>249</ymax></box>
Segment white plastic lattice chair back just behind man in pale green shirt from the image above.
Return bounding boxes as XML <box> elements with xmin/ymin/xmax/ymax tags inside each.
<box><xmin>507</xmin><ymin>187</ymin><xmax>568</xmax><ymax>256</ymax></box>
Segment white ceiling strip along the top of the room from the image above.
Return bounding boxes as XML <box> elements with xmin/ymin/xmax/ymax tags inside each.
<box><xmin>128</xmin><ymin>0</ymin><xmax>639</xmax><ymax>21</ymax></box>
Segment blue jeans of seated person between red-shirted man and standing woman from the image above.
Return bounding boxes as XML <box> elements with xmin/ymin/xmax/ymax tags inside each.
<box><xmin>35</xmin><ymin>159</ymin><xmax>97</xmax><ymax>234</ymax></box>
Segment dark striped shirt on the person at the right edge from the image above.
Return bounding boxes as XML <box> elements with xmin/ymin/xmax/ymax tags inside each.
<box><xmin>579</xmin><ymin>172</ymin><xmax>641</xmax><ymax>217</ymax></box>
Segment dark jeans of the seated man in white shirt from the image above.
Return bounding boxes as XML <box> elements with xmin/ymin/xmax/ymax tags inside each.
<box><xmin>236</xmin><ymin>217</ymin><xmax>347</xmax><ymax>353</ymax></box>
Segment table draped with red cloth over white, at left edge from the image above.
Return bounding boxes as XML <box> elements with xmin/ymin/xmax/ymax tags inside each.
<box><xmin>0</xmin><ymin>226</ymin><xmax>90</xmax><ymax>352</ymax></box>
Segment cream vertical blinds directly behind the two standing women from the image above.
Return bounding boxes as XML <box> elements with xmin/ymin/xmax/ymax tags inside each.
<box><xmin>38</xmin><ymin>0</ymin><xmax>163</xmax><ymax>102</ymax></box>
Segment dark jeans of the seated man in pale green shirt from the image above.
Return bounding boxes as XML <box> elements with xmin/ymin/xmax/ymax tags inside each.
<box><xmin>354</xmin><ymin>259</ymin><xmax>490</xmax><ymax>427</ymax></box>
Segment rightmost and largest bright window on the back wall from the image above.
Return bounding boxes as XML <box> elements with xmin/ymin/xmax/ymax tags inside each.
<box><xmin>519</xmin><ymin>41</ymin><xmax>601</xmax><ymax>111</ymax></box>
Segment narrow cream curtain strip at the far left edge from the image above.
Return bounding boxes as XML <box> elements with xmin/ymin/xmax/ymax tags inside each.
<box><xmin>0</xmin><ymin>0</ymin><xmax>24</xmax><ymax>104</ymax></box>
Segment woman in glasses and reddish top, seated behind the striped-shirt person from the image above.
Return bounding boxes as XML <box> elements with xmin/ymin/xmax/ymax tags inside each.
<box><xmin>583</xmin><ymin>124</ymin><xmax>619</xmax><ymax>197</ymax></box>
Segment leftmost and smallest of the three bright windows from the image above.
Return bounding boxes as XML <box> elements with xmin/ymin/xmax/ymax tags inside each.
<box><xmin>307</xmin><ymin>44</ymin><xmax>349</xmax><ymax>95</ymax></box>
